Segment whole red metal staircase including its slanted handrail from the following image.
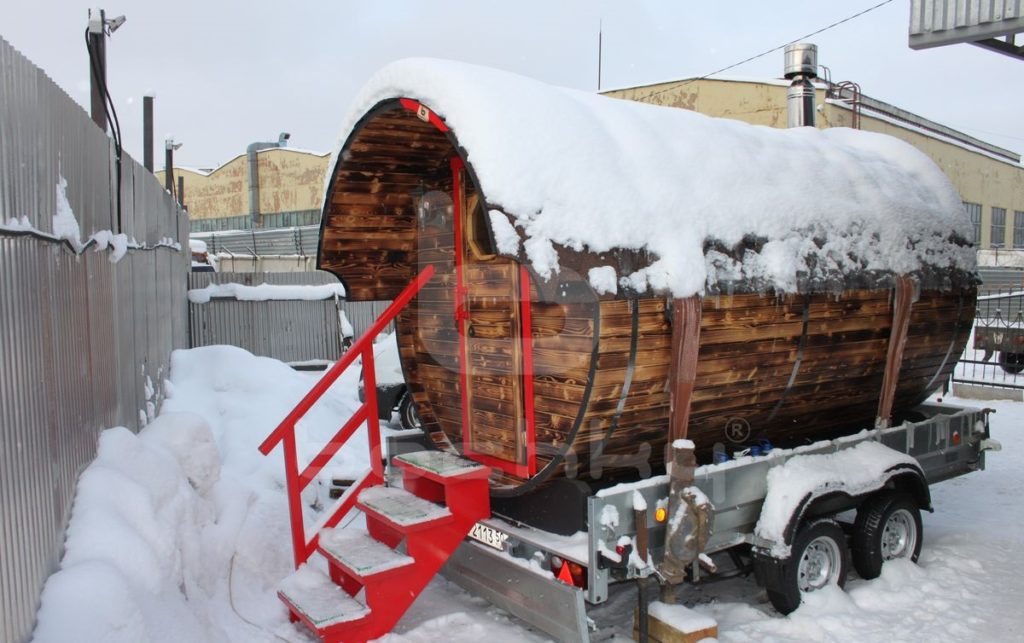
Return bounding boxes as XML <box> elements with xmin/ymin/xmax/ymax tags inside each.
<box><xmin>260</xmin><ymin>266</ymin><xmax>490</xmax><ymax>643</ymax></box>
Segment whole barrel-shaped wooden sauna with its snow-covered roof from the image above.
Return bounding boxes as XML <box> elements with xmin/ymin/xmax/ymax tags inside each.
<box><xmin>317</xmin><ymin>60</ymin><xmax>977</xmax><ymax>497</ymax></box>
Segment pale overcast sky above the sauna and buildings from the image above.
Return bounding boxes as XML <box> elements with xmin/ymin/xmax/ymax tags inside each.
<box><xmin>8</xmin><ymin>0</ymin><xmax>1024</xmax><ymax>168</ymax></box>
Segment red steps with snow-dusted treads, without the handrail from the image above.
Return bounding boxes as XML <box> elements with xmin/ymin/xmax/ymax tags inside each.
<box><xmin>278</xmin><ymin>452</ymin><xmax>490</xmax><ymax>643</ymax></box>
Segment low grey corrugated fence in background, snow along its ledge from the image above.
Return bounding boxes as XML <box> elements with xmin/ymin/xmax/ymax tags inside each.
<box><xmin>188</xmin><ymin>271</ymin><xmax>389</xmax><ymax>363</ymax></box>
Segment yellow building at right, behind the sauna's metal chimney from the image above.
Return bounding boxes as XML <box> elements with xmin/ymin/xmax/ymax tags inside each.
<box><xmin>604</xmin><ymin>79</ymin><xmax>1024</xmax><ymax>253</ymax></box>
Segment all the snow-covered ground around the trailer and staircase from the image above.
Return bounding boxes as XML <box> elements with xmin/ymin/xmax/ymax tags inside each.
<box><xmin>36</xmin><ymin>346</ymin><xmax>1024</xmax><ymax>643</ymax></box>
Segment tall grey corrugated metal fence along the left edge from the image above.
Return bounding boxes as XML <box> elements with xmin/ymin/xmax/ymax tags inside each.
<box><xmin>0</xmin><ymin>39</ymin><xmax>188</xmax><ymax>641</ymax></box>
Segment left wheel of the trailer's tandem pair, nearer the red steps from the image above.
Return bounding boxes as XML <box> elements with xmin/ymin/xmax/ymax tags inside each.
<box><xmin>763</xmin><ymin>519</ymin><xmax>850</xmax><ymax>614</ymax></box>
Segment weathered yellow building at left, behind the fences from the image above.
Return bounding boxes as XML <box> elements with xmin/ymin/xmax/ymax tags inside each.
<box><xmin>157</xmin><ymin>147</ymin><xmax>331</xmax><ymax>232</ymax></box>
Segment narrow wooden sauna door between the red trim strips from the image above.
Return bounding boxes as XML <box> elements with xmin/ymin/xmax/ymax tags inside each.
<box><xmin>456</xmin><ymin>181</ymin><xmax>528</xmax><ymax>477</ymax></box>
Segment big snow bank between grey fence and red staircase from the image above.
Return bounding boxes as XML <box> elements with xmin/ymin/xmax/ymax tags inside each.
<box><xmin>36</xmin><ymin>346</ymin><xmax>380</xmax><ymax>643</ymax></box>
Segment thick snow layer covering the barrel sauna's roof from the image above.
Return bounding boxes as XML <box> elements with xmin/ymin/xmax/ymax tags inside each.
<box><xmin>328</xmin><ymin>58</ymin><xmax>975</xmax><ymax>297</ymax></box>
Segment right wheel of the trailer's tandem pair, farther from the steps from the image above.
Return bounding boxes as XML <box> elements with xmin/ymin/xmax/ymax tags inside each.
<box><xmin>851</xmin><ymin>491</ymin><xmax>924</xmax><ymax>581</ymax></box>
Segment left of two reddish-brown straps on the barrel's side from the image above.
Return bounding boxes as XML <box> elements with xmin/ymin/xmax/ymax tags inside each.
<box><xmin>669</xmin><ymin>295</ymin><xmax>701</xmax><ymax>444</ymax></box>
